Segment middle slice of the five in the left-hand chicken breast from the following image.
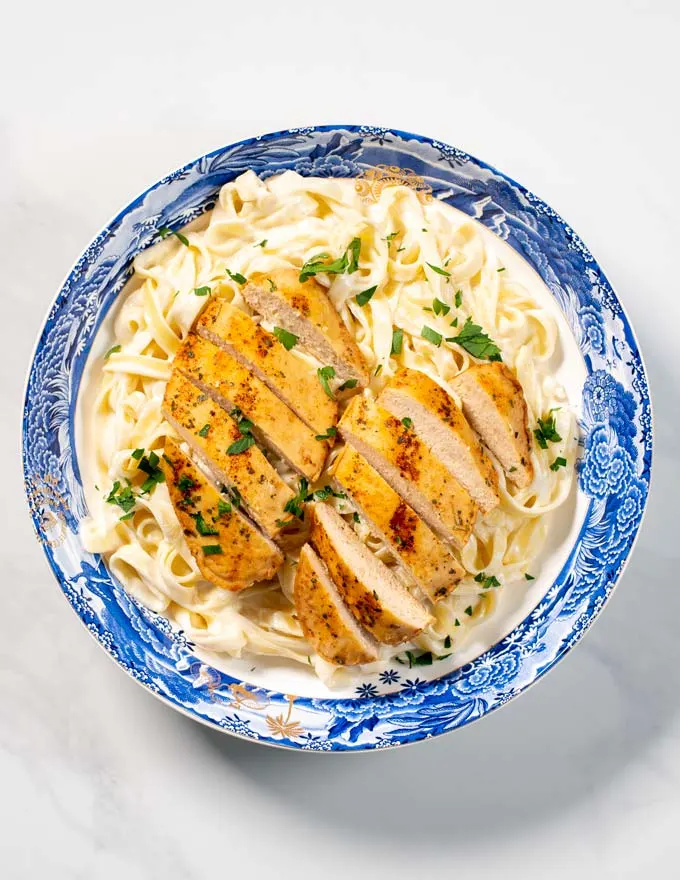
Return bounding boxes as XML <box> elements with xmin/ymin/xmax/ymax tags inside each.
<box><xmin>173</xmin><ymin>333</ymin><xmax>328</xmax><ymax>481</ymax></box>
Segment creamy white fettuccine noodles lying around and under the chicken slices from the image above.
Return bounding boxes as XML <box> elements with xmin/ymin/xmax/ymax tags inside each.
<box><xmin>83</xmin><ymin>171</ymin><xmax>575</xmax><ymax>684</ymax></box>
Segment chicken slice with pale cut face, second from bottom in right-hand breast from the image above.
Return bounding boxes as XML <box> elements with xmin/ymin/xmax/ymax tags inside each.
<box><xmin>311</xmin><ymin>503</ymin><xmax>432</xmax><ymax>645</ymax></box>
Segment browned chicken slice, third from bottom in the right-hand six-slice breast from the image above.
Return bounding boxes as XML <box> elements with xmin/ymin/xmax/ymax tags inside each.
<box><xmin>333</xmin><ymin>443</ymin><xmax>465</xmax><ymax>602</ymax></box>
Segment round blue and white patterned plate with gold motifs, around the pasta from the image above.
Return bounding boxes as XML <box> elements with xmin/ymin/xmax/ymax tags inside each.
<box><xmin>23</xmin><ymin>125</ymin><xmax>652</xmax><ymax>751</ymax></box>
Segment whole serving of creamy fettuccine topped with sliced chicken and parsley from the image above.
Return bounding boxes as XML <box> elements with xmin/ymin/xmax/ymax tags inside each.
<box><xmin>83</xmin><ymin>171</ymin><xmax>575</xmax><ymax>683</ymax></box>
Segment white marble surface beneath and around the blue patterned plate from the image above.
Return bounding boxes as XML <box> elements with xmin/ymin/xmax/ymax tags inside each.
<box><xmin>0</xmin><ymin>0</ymin><xmax>680</xmax><ymax>880</ymax></box>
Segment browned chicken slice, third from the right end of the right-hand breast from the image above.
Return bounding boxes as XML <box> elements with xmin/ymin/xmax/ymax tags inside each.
<box><xmin>338</xmin><ymin>396</ymin><xmax>478</xmax><ymax>547</ymax></box>
